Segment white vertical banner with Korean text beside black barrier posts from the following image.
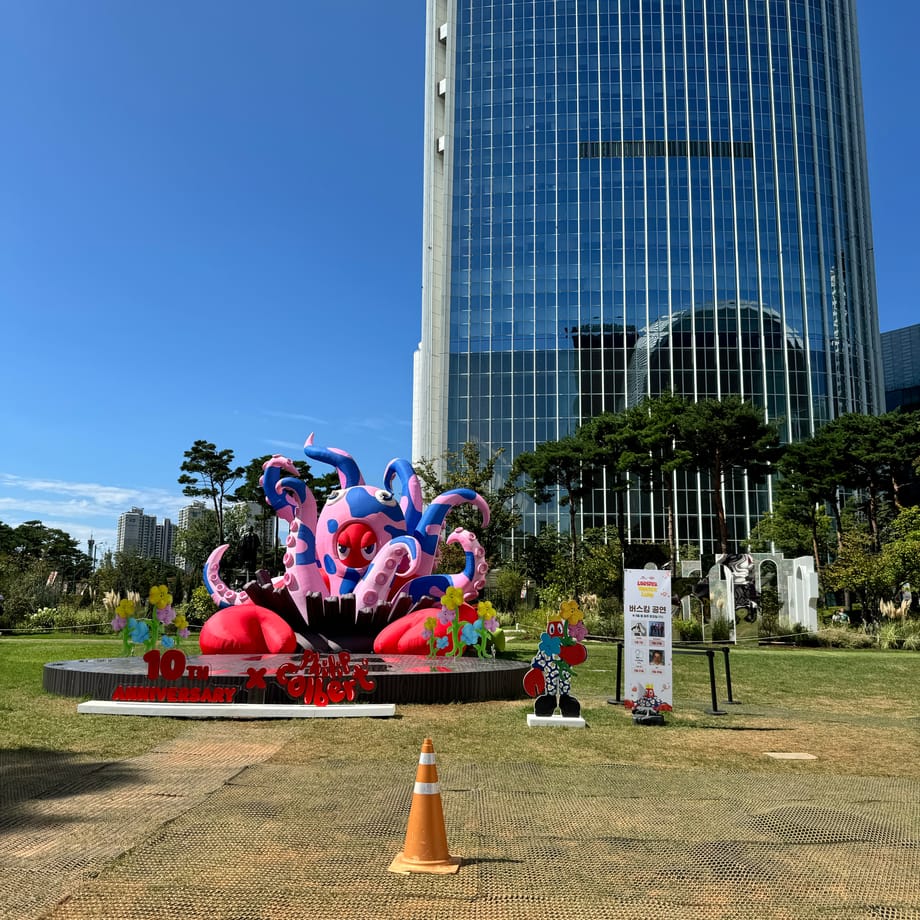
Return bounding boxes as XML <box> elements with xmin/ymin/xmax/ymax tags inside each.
<box><xmin>623</xmin><ymin>569</ymin><xmax>673</xmax><ymax>720</ymax></box>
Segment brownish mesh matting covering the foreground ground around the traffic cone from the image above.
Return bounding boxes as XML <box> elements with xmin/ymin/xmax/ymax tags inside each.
<box><xmin>0</xmin><ymin>723</ymin><xmax>920</xmax><ymax>920</ymax></box>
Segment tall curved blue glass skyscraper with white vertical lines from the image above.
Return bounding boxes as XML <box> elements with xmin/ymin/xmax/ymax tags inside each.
<box><xmin>413</xmin><ymin>0</ymin><xmax>884</xmax><ymax>551</ymax></box>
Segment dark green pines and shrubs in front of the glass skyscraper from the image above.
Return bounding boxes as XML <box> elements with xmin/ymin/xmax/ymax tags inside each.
<box><xmin>420</xmin><ymin>393</ymin><xmax>920</xmax><ymax>615</ymax></box>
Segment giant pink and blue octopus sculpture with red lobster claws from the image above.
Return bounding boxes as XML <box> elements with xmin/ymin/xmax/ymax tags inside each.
<box><xmin>199</xmin><ymin>434</ymin><xmax>489</xmax><ymax>654</ymax></box>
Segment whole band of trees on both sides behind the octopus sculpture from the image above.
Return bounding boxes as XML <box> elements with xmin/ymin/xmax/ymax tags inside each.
<box><xmin>0</xmin><ymin>408</ymin><xmax>920</xmax><ymax>629</ymax></box>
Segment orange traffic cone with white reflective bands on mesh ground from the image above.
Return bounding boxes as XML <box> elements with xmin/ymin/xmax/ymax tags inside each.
<box><xmin>389</xmin><ymin>738</ymin><xmax>460</xmax><ymax>874</ymax></box>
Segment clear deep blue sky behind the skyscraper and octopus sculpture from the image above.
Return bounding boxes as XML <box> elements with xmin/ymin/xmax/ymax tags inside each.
<box><xmin>0</xmin><ymin>0</ymin><xmax>920</xmax><ymax>548</ymax></box>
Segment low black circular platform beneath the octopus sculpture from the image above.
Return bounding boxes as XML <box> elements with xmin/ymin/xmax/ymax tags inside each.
<box><xmin>42</xmin><ymin>654</ymin><xmax>530</xmax><ymax>704</ymax></box>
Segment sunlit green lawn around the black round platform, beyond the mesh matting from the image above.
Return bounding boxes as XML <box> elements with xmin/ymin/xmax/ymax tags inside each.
<box><xmin>0</xmin><ymin>636</ymin><xmax>920</xmax><ymax>776</ymax></box>
